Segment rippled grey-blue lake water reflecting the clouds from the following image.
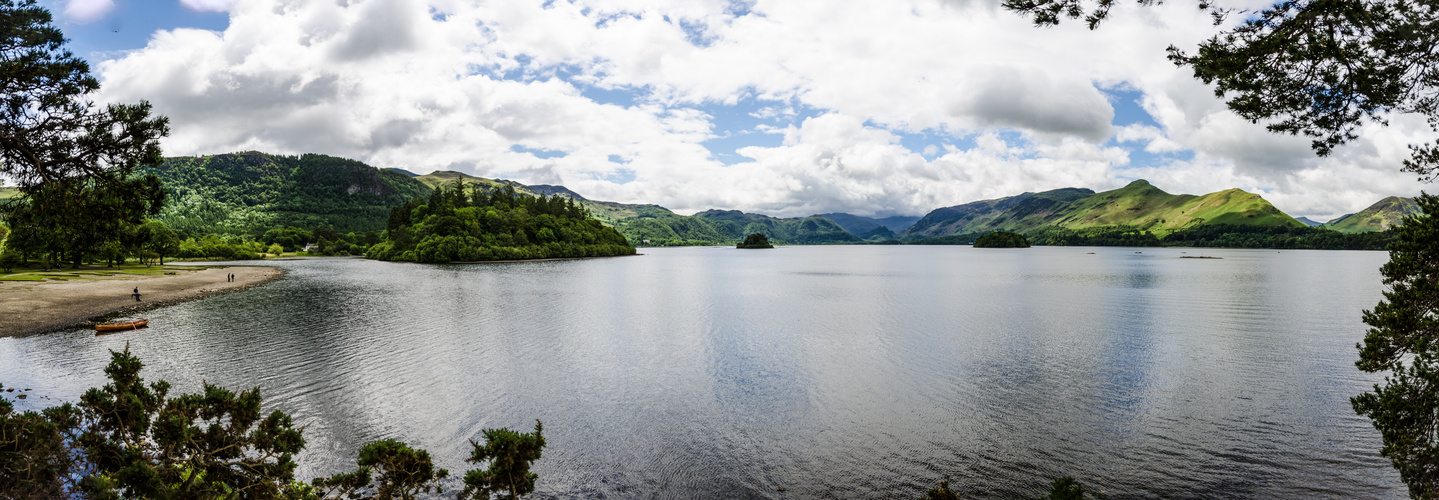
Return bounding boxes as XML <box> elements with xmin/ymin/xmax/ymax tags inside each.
<box><xmin>0</xmin><ymin>246</ymin><xmax>1406</xmax><ymax>499</ymax></box>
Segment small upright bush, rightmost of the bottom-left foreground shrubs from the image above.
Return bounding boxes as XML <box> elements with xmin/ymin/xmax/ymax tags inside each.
<box><xmin>459</xmin><ymin>421</ymin><xmax>544</xmax><ymax>500</ymax></box>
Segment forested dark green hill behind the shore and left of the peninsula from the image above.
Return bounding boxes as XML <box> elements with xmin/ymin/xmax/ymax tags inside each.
<box><xmin>141</xmin><ymin>151</ymin><xmax>430</xmax><ymax>233</ymax></box>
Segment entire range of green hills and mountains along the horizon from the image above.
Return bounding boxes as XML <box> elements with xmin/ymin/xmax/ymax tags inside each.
<box><xmin>132</xmin><ymin>151</ymin><xmax>1417</xmax><ymax>245</ymax></box>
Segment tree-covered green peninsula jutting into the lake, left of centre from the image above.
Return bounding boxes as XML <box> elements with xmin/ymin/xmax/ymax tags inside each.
<box><xmin>366</xmin><ymin>182</ymin><xmax>635</xmax><ymax>262</ymax></box>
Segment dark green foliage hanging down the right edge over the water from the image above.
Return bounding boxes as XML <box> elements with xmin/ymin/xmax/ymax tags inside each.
<box><xmin>1350</xmin><ymin>195</ymin><xmax>1439</xmax><ymax>499</ymax></box>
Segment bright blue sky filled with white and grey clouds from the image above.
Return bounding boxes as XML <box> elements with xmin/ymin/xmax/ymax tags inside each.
<box><xmin>42</xmin><ymin>0</ymin><xmax>1436</xmax><ymax>222</ymax></box>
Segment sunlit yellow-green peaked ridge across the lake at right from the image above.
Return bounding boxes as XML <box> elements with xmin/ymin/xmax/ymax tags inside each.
<box><xmin>899</xmin><ymin>180</ymin><xmax>1304</xmax><ymax>239</ymax></box>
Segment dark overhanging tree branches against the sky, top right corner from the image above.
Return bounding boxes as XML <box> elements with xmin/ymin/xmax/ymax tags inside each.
<box><xmin>1004</xmin><ymin>0</ymin><xmax>1439</xmax><ymax>180</ymax></box>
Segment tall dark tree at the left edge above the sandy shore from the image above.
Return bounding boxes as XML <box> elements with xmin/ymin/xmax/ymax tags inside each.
<box><xmin>0</xmin><ymin>0</ymin><xmax>168</xmax><ymax>267</ymax></box>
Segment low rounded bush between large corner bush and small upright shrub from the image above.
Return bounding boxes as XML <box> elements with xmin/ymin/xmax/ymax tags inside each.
<box><xmin>314</xmin><ymin>439</ymin><xmax>449</xmax><ymax>500</ymax></box>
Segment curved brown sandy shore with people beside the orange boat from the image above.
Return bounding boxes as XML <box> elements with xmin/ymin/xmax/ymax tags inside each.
<box><xmin>0</xmin><ymin>267</ymin><xmax>282</xmax><ymax>337</ymax></box>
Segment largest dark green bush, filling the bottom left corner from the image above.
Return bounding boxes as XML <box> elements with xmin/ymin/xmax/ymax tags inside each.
<box><xmin>0</xmin><ymin>350</ymin><xmax>305</xmax><ymax>499</ymax></box>
